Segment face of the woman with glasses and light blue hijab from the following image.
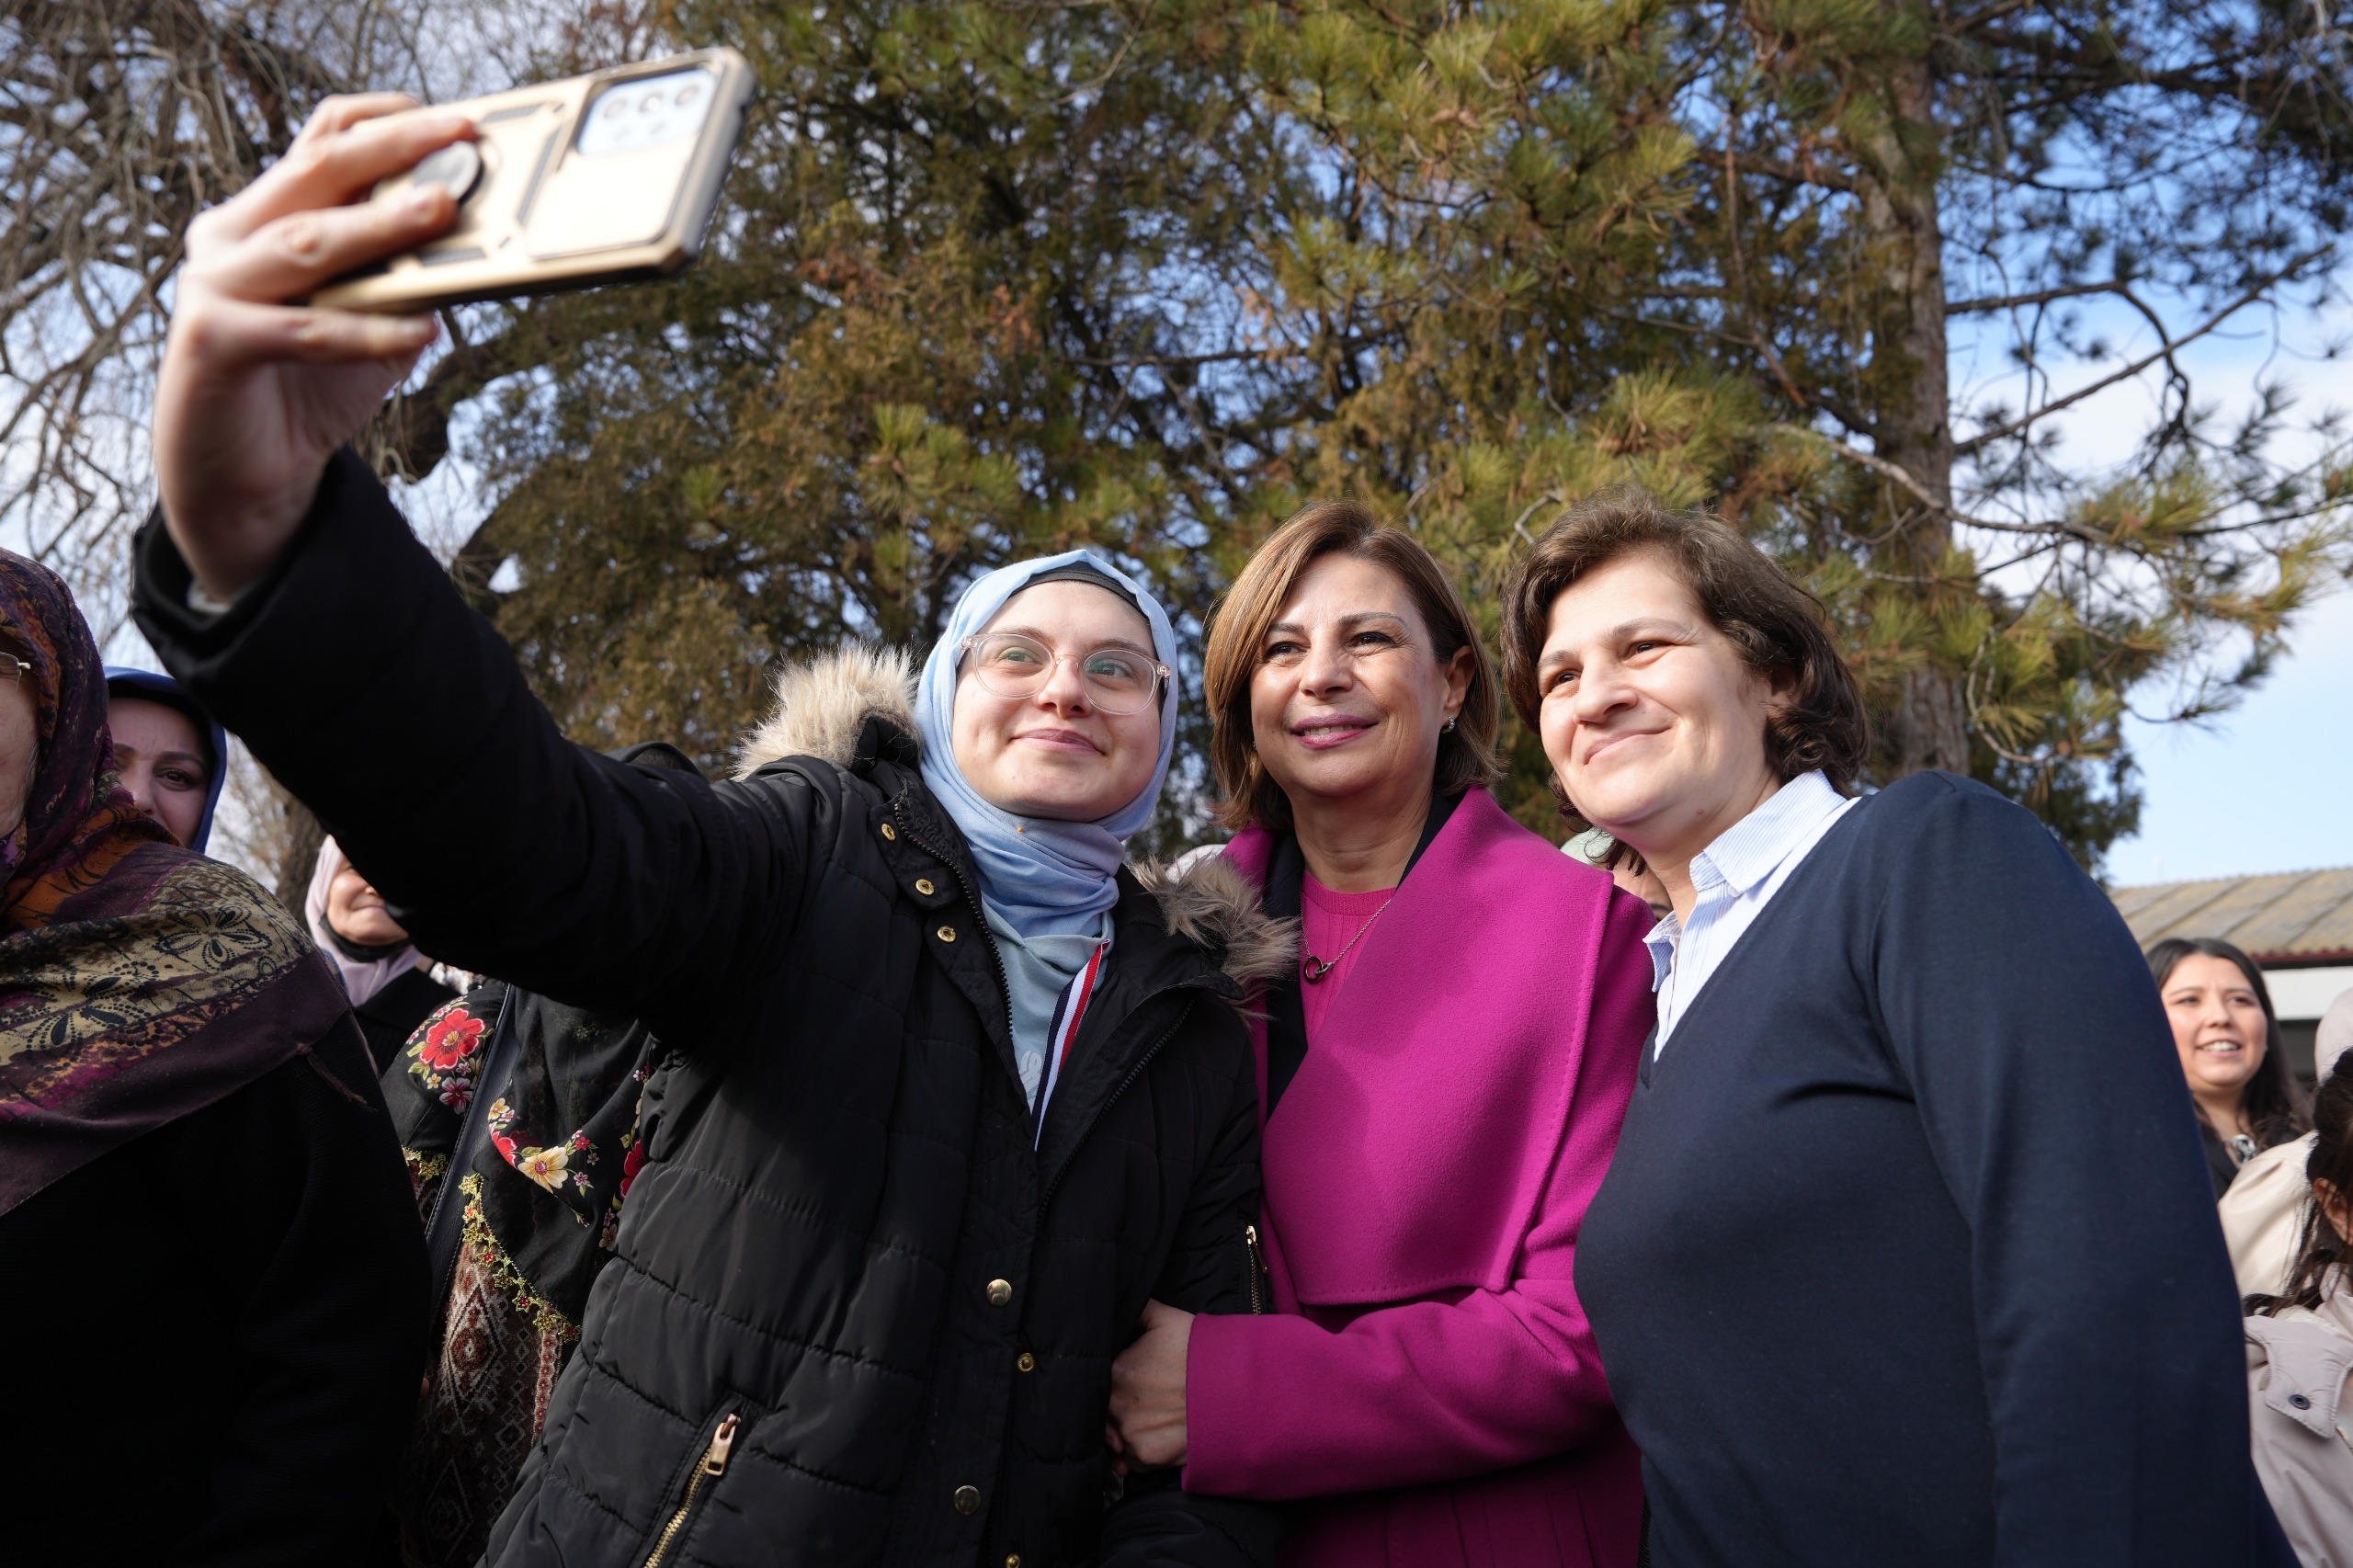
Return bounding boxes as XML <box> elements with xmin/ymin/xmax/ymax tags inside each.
<box><xmin>950</xmin><ymin>582</ymin><xmax>1172</xmax><ymax>822</ymax></box>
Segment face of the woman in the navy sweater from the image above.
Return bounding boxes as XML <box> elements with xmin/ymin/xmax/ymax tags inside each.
<box><xmin>1537</xmin><ymin>551</ymin><xmax>1779</xmax><ymax>864</ymax></box>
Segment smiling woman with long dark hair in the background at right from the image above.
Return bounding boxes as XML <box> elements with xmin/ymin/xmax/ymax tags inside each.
<box><xmin>2148</xmin><ymin>937</ymin><xmax>2311</xmax><ymax>1199</ymax></box>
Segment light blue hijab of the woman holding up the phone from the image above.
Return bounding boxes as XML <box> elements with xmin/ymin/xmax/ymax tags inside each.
<box><xmin>915</xmin><ymin>551</ymin><xmax>1176</xmax><ymax>939</ymax></box>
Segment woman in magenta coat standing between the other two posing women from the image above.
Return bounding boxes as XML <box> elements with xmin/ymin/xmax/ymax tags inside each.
<box><xmin>1110</xmin><ymin>504</ymin><xmax>1652</xmax><ymax>1568</ymax></box>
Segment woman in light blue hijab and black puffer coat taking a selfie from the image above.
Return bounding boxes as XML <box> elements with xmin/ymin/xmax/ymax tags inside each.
<box><xmin>139</xmin><ymin>99</ymin><xmax>1282</xmax><ymax>1568</ymax></box>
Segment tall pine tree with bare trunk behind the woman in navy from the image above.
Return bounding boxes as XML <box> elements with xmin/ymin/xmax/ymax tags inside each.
<box><xmin>1223</xmin><ymin>0</ymin><xmax>2353</xmax><ymax>864</ymax></box>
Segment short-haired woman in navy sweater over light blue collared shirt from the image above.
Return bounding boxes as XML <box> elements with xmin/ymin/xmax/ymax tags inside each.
<box><xmin>1504</xmin><ymin>492</ymin><xmax>2294</xmax><ymax>1568</ymax></box>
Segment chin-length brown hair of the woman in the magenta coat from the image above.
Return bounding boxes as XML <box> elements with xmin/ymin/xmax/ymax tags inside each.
<box><xmin>1202</xmin><ymin>502</ymin><xmax>1504</xmax><ymax>831</ymax></box>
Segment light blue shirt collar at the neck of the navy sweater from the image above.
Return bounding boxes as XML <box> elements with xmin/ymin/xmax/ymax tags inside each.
<box><xmin>1643</xmin><ymin>770</ymin><xmax>1854</xmax><ymax>1055</ymax></box>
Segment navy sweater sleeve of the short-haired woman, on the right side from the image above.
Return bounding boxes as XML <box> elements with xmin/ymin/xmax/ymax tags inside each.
<box><xmin>1857</xmin><ymin>777</ymin><xmax>2278</xmax><ymax>1565</ymax></box>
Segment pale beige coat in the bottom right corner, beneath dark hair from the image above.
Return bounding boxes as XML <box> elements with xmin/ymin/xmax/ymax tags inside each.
<box><xmin>2247</xmin><ymin>1274</ymin><xmax>2353</xmax><ymax>1568</ymax></box>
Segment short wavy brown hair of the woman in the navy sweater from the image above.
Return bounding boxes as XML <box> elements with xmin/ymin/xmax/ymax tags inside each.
<box><xmin>1504</xmin><ymin>485</ymin><xmax>1870</xmax><ymax>831</ymax></box>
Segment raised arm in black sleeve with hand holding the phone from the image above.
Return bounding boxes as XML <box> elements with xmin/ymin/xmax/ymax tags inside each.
<box><xmin>136</xmin><ymin>94</ymin><xmax>831</xmax><ymax>1026</ymax></box>
